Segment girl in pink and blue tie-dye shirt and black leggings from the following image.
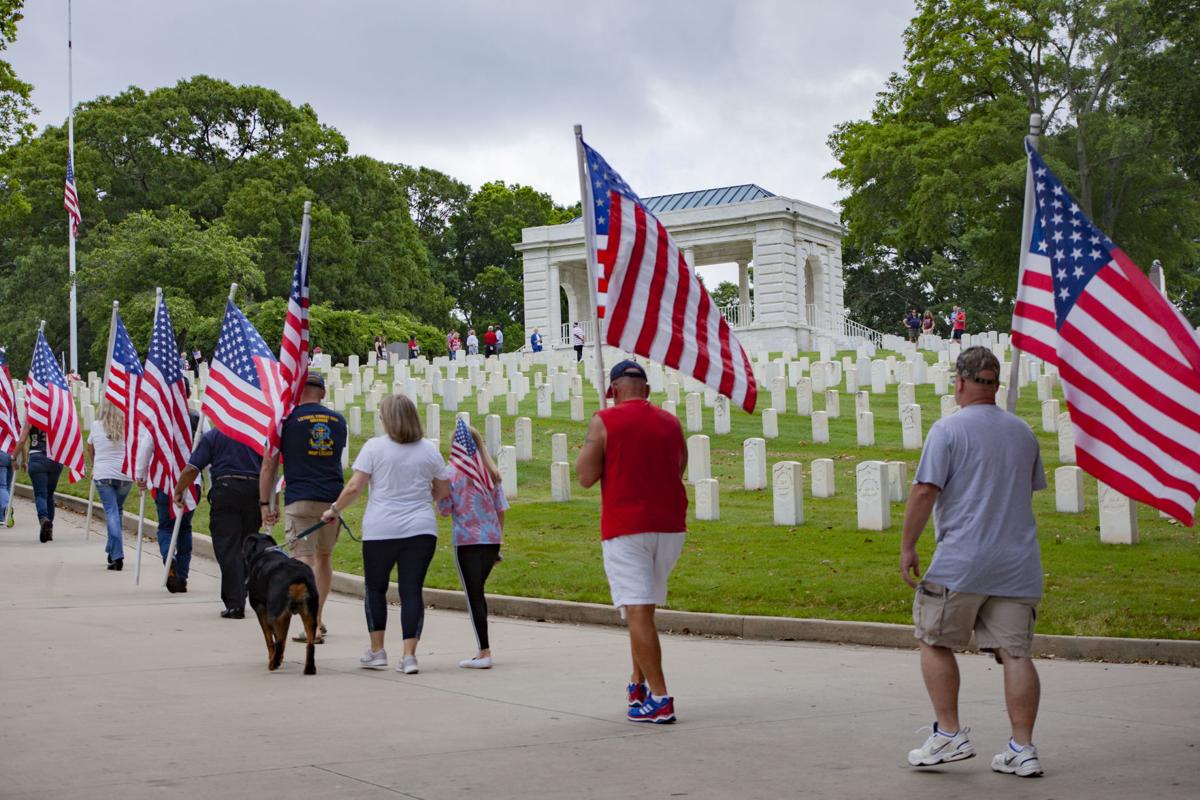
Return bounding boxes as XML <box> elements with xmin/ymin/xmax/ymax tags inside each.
<box><xmin>438</xmin><ymin>427</ymin><xmax>509</xmax><ymax>669</ymax></box>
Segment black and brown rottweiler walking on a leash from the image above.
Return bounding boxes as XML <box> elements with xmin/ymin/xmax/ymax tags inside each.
<box><xmin>241</xmin><ymin>534</ymin><xmax>317</xmax><ymax>675</ymax></box>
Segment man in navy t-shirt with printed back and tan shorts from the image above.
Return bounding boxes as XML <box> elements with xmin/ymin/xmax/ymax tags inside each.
<box><xmin>258</xmin><ymin>372</ymin><xmax>348</xmax><ymax>643</ymax></box>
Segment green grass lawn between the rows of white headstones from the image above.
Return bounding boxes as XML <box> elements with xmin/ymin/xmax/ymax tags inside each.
<box><xmin>49</xmin><ymin>354</ymin><xmax>1200</xmax><ymax>638</ymax></box>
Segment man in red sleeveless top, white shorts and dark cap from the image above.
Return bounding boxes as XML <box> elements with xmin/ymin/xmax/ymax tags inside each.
<box><xmin>575</xmin><ymin>361</ymin><xmax>688</xmax><ymax>723</ymax></box>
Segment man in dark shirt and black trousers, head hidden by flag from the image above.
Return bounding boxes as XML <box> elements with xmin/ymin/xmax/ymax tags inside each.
<box><xmin>174</xmin><ymin>428</ymin><xmax>263</xmax><ymax>619</ymax></box>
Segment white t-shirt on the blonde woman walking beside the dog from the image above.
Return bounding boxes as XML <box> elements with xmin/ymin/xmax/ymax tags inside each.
<box><xmin>354</xmin><ymin>435</ymin><xmax>450</xmax><ymax>541</ymax></box>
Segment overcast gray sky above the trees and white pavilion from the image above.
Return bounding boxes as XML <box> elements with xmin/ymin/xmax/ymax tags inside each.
<box><xmin>7</xmin><ymin>0</ymin><xmax>912</xmax><ymax>212</ymax></box>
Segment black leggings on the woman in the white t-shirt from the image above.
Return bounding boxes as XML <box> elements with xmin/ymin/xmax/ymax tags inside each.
<box><xmin>362</xmin><ymin>535</ymin><xmax>438</xmax><ymax>639</ymax></box>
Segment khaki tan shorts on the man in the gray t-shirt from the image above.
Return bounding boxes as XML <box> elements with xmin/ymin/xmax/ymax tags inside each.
<box><xmin>912</xmin><ymin>582</ymin><xmax>1038</xmax><ymax>661</ymax></box>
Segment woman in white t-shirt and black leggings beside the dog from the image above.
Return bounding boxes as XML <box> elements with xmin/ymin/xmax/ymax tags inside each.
<box><xmin>324</xmin><ymin>395</ymin><xmax>450</xmax><ymax>675</ymax></box>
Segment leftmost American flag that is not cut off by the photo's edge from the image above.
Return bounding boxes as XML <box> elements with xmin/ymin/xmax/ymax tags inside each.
<box><xmin>25</xmin><ymin>331</ymin><xmax>85</xmax><ymax>483</ymax></box>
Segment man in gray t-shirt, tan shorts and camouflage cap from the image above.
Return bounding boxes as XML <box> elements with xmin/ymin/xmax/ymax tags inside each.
<box><xmin>900</xmin><ymin>347</ymin><xmax>1046</xmax><ymax>777</ymax></box>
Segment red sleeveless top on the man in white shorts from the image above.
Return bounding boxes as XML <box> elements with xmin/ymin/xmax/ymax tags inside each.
<box><xmin>600</xmin><ymin>401</ymin><xmax>688</xmax><ymax>539</ymax></box>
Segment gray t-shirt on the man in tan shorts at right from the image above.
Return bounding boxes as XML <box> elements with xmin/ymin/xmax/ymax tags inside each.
<box><xmin>913</xmin><ymin>403</ymin><xmax>1046</xmax><ymax>597</ymax></box>
